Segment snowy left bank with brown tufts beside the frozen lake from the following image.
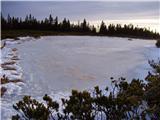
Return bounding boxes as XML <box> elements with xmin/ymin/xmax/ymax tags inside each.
<box><xmin>0</xmin><ymin>40</ymin><xmax>23</xmax><ymax>97</ymax></box>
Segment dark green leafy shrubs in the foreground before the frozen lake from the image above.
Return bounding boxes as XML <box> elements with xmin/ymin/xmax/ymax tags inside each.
<box><xmin>12</xmin><ymin>61</ymin><xmax>160</xmax><ymax>120</ymax></box>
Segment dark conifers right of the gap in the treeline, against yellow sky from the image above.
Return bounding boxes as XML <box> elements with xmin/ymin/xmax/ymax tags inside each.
<box><xmin>99</xmin><ymin>21</ymin><xmax>160</xmax><ymax>39</ymax></box>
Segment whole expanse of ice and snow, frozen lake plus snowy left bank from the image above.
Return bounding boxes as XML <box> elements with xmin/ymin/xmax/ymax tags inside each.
<box><xmin>1</xmin><ymin>36</ymin><xmax>160</xmax><ymax>120</ymax></box>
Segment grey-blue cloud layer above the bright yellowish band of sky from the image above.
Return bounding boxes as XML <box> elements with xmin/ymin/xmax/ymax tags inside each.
<box><xmin>2</xmin><ymin>1</ymin><xmax>159</xmax><ymax>20</ymax></box>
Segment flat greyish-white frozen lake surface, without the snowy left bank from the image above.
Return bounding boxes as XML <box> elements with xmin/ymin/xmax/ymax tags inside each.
<box><xmin>17</xmin><ymin>36</ymin><xmax>158</xmax><ymax>94</ymax></box>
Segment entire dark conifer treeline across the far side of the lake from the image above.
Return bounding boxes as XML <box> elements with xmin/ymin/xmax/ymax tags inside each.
<box><xmin>1</xmin><ymin>14</ymin><xmax>160</xmax><ymax>39</ymax></box>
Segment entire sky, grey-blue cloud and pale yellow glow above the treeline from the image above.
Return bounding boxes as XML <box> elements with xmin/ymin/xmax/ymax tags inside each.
<box><xmin>1</xmin><ymin>1</ymin><xmax>160</xmax><ymax>33</ymax></box>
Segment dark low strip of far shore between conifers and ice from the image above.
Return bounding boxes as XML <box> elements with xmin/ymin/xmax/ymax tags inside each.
<box><xmin>1</xmin><ymin>30</ymin><xmax>160</xmax><ymax>41</ymax></box>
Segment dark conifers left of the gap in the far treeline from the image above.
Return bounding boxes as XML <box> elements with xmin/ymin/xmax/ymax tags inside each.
<box><xmin>1</xmin><ymin>14</ymin><xmax>96</xmax><ymax>34</ymax></box>
